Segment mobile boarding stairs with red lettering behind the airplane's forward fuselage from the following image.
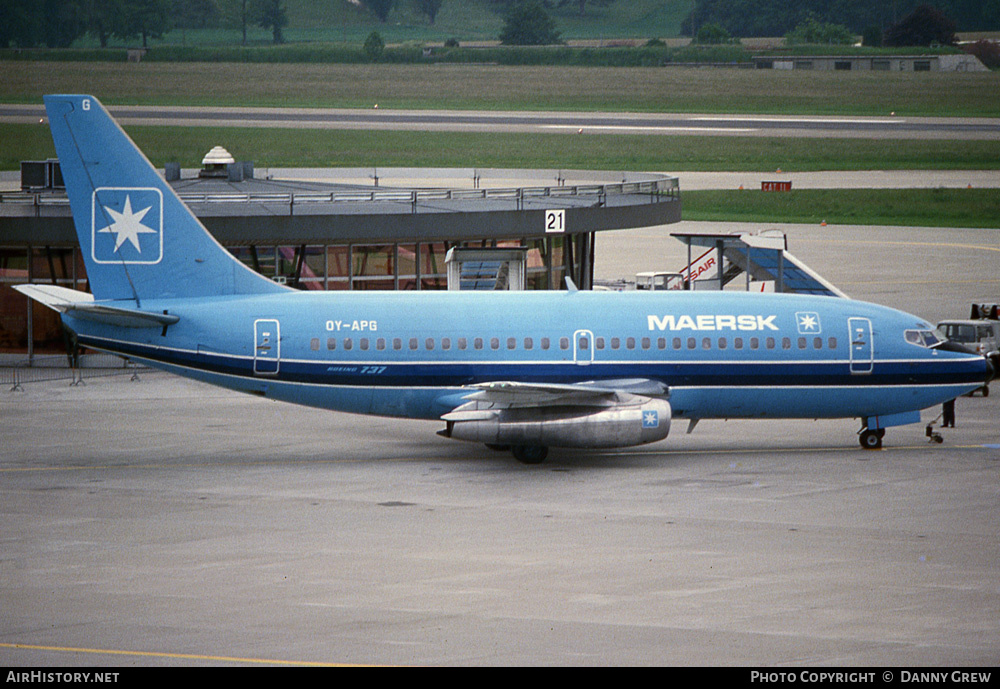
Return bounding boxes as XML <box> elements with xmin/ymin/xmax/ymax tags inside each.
<box><xmin>671</xmin><ymin>231</ymin><xmax>847</xmax><ymax>297</ymax></box>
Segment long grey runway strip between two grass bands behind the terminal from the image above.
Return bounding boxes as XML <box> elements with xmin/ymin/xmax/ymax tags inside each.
<box><xmin>7</xmin><ymin>104</ymin><xmax>1000</xmax><ymax>140</ymax></box>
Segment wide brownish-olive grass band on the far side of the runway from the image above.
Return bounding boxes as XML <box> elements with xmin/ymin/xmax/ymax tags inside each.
<box><xmin>0</xmin><ymin>62</ymin><xmax>1000</xmax><ymax>117</ymax></box>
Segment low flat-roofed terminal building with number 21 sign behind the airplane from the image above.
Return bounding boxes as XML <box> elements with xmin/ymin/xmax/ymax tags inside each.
<box><xmin>0</xmin><ymin>161</ymin><xmax>681</xmax><ymax>355</ymax></box>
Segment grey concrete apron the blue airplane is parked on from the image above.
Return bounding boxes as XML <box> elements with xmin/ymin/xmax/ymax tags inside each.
<box><xmin>0</xmin><ymin>224</ymin><xmax>1000</xmax><ymax>672</ymax></box>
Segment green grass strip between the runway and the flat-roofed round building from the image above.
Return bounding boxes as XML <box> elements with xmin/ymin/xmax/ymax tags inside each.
<box><xmin>0</xmin><ymin>124</ymin><xmax>1000</xmax><ymax>172</ymax></box>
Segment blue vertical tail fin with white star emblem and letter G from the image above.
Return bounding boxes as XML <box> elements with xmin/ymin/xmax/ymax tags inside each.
<box><xmin>45</xmin><ymin>95</ymin><xmax>286</xmax><ymax>304</ymax></box>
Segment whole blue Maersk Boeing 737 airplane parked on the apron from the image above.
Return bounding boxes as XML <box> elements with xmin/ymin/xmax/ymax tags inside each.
<box><xmin>18</xmin><ymin>95</ymin><xmax>997</xmax><ymax>463</ymax></box>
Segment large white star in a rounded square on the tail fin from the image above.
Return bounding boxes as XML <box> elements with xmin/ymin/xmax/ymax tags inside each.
<box><xmin>91</xmin><ymin>187</ymin><xmax>163</xmax><ymax>265</ymax></box>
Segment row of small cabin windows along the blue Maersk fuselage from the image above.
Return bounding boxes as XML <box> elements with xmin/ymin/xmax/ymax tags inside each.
<box><xmin>309</xmin><ymin>337</ymin><xmax>837</xmax><ymax>352</ymax></box>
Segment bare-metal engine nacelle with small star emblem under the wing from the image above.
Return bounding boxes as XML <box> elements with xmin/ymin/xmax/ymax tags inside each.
<box><xmin>443</xmin><ymin>398</ymin><xmax>670</xmax><ymax>448</ymax></box>
